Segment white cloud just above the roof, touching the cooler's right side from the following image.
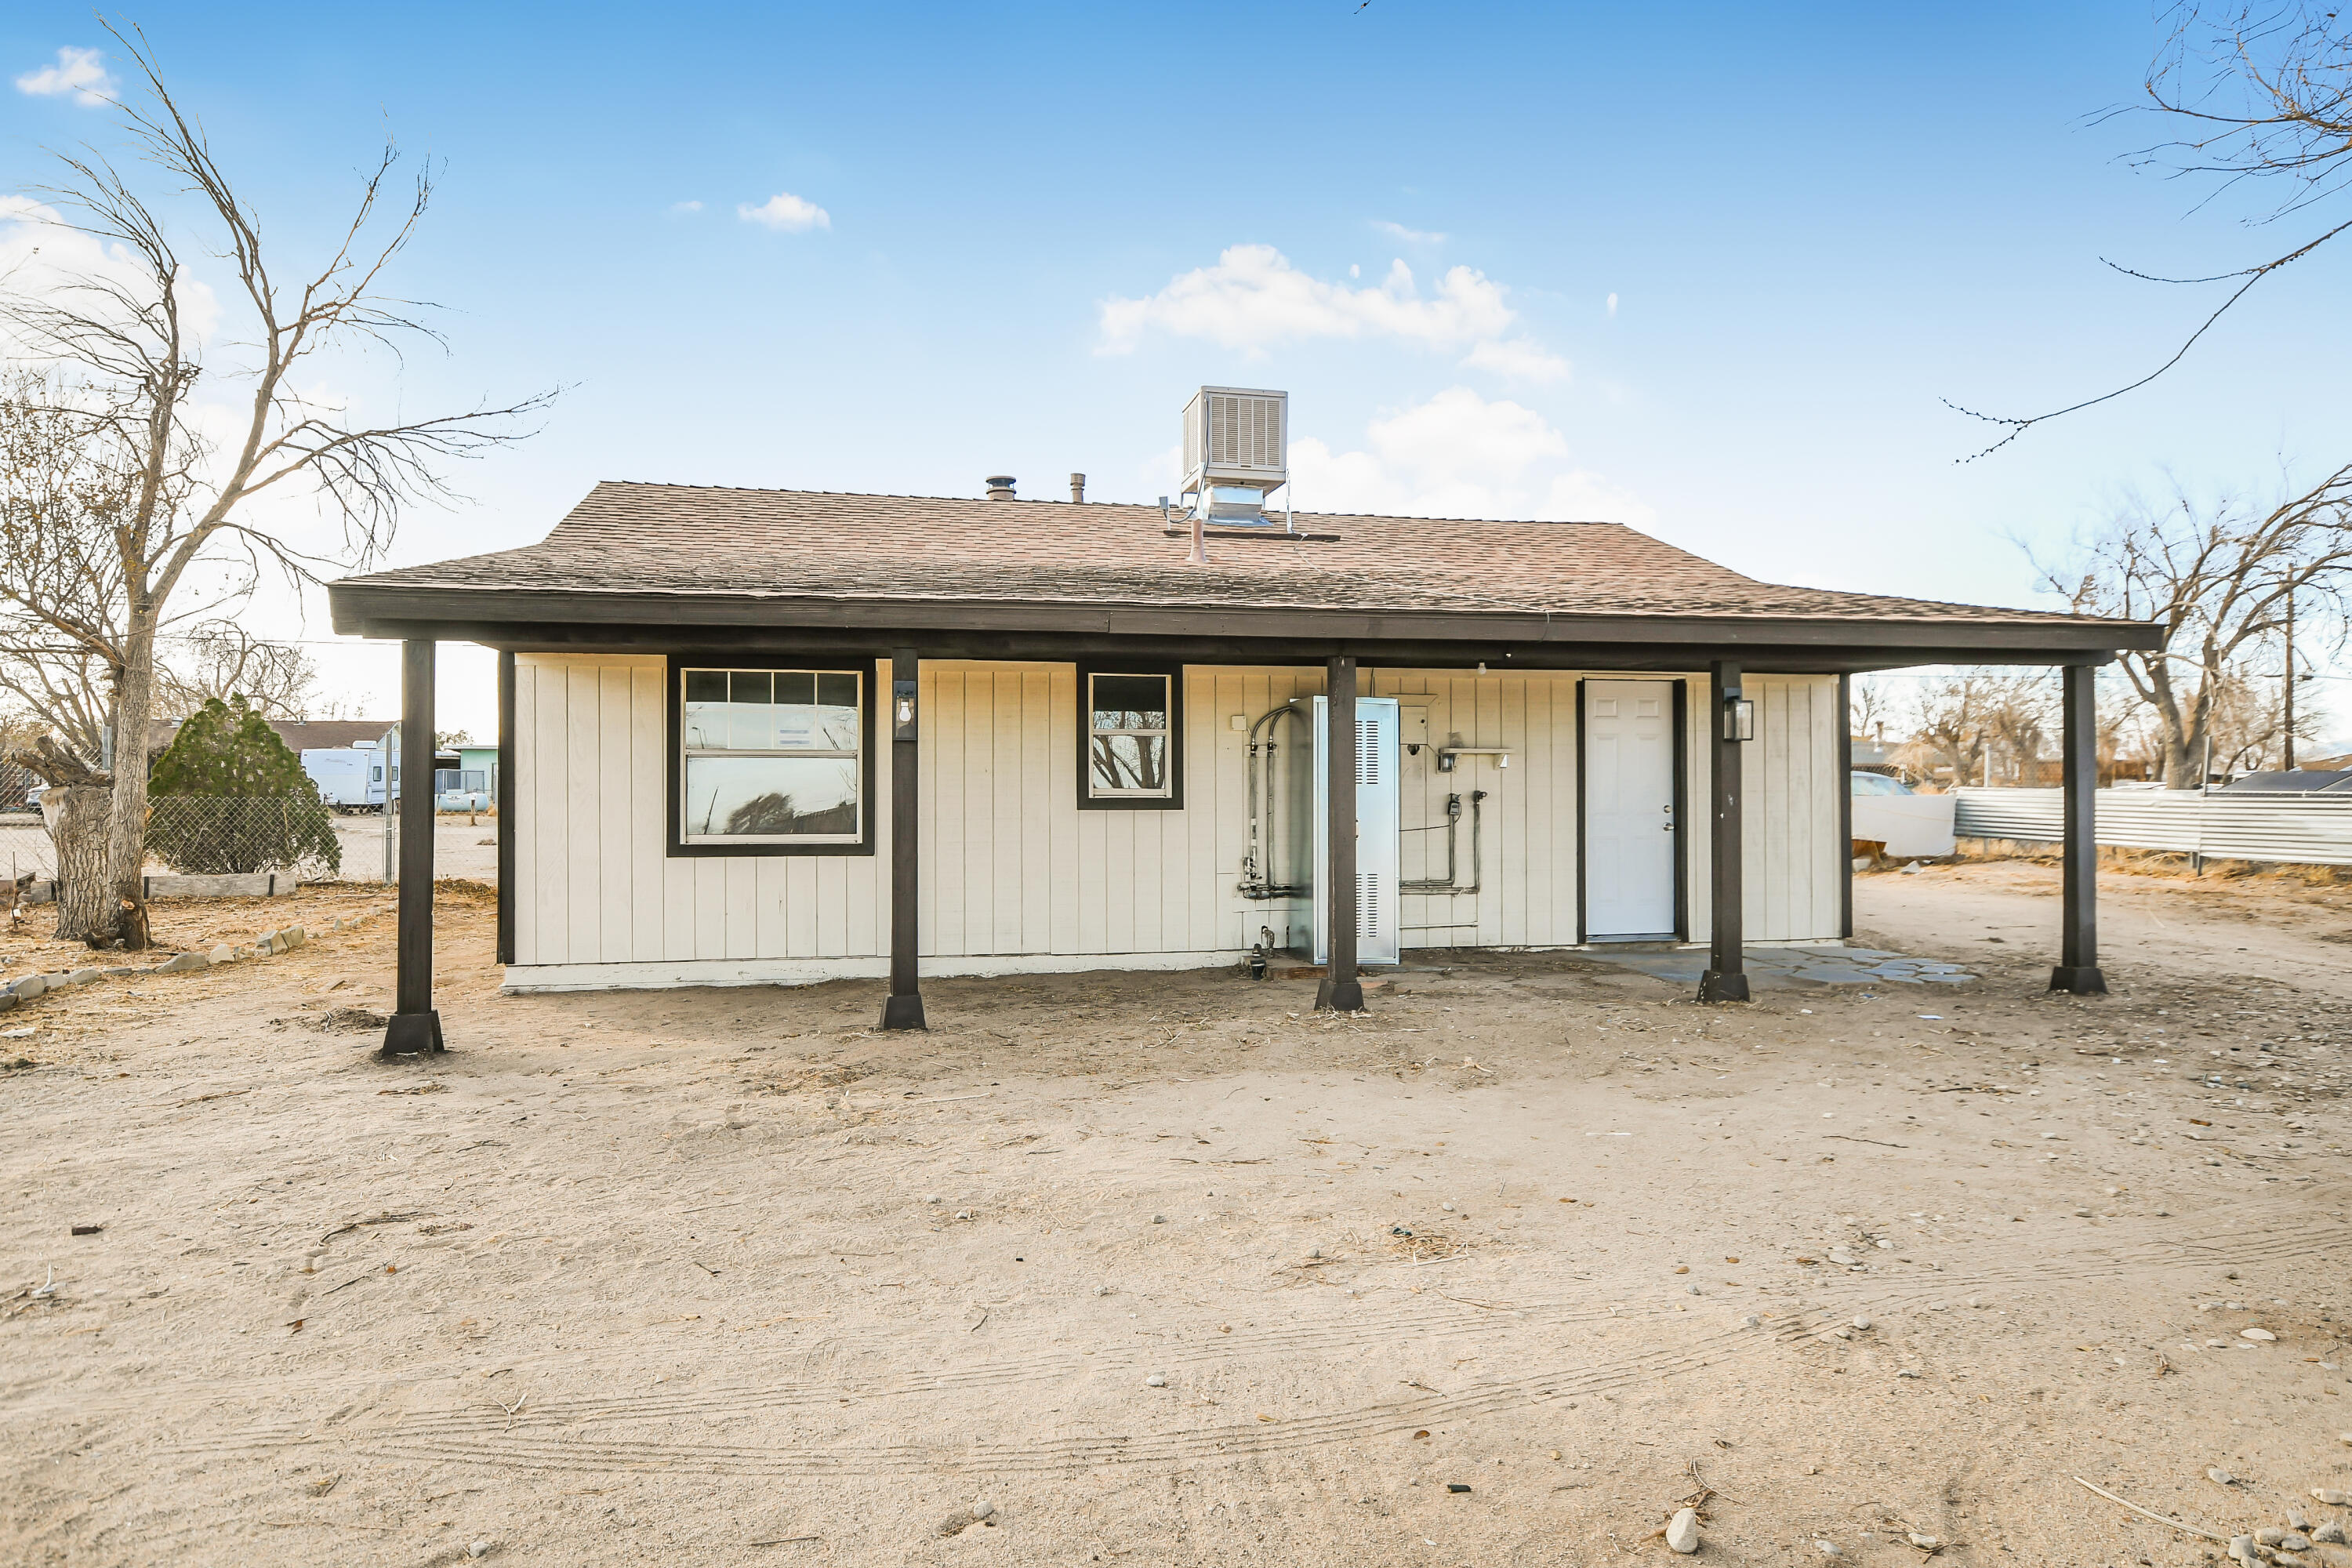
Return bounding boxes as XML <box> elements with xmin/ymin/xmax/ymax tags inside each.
<box><xmin>1291</xmin><ymin>386</ymin><xmax>1653</xmax><ymax>527</ymax></box>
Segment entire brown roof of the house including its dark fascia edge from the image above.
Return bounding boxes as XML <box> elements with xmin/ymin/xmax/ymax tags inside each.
<box><xmin>329</xmin><ymin>485</ymin><xmax>2161</xmax><ymax>673</ymax></box>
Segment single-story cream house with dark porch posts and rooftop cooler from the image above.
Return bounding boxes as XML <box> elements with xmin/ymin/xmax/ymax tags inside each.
<box><xmin>329</xmin><ymin>388</ymin><xmax>2157</xmax><ymax>1067</ymax></box>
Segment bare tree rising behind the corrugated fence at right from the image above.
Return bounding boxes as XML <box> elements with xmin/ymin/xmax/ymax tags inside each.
<box><xmin>2042</xmin><ymin>466</ymin><xmax>2352</xmax><ymax>789</ymax></box>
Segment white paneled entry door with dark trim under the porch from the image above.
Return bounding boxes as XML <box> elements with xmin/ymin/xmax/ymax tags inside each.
<box><xmin>1585</xmin><ymin>680</ymin><xmax>1682</xmax><ymax>938</ymax></box>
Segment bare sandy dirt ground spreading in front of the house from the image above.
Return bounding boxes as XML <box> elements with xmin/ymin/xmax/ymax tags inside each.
<box><xmin>0</xmin><ymin>862</ymin><xmax>2352</xmax><ymax>1568</ymax></box>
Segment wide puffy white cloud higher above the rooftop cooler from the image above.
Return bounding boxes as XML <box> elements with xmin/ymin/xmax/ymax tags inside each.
<box><xmin>1098</xmin><ymin>245</ymin><xmax>1569</xmax><ymax>381</ymax></box>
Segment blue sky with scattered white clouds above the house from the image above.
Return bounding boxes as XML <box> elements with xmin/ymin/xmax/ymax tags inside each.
<box><xmin>0</xmin><ymin>0</ymin><xmax>2352</xmax><ymax>734</ymax></box>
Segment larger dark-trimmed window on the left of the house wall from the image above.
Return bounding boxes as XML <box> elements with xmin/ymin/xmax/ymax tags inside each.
<box><xmin>675</xmin><ymin>663</ymin><xmax>866</xmax><ymax>853</ymax></box>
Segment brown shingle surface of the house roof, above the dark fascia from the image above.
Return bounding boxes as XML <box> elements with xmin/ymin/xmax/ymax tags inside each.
<box><xmin>341</xmin><ymin>482</ymin><xmax>2131</xmax><ymax>628</ymax></box>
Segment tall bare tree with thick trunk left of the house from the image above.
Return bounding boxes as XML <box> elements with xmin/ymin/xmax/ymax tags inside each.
<box><xmin>0</xmin><ymin>31</ymin><xmax>548</xmax><ymax>947</ymax></box>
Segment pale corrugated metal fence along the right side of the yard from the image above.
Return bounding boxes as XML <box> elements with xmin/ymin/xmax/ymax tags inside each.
<box><xmin>1952</xmin><ymin>789</ymin><xmax>2352</xmax><ymax>865</ymax></box>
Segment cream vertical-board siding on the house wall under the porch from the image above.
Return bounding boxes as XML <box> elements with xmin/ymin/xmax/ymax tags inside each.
<box><xmin>508</xmin><ymin>654</ymin><xmax>1842</xmax><ymax>987</ymax></box>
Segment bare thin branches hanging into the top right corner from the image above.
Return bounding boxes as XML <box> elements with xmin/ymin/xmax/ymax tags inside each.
<box><xmin>1945</xmin><ymin>0</ymin><xmax>2352</xmax><ymax>461</ymax></box>
